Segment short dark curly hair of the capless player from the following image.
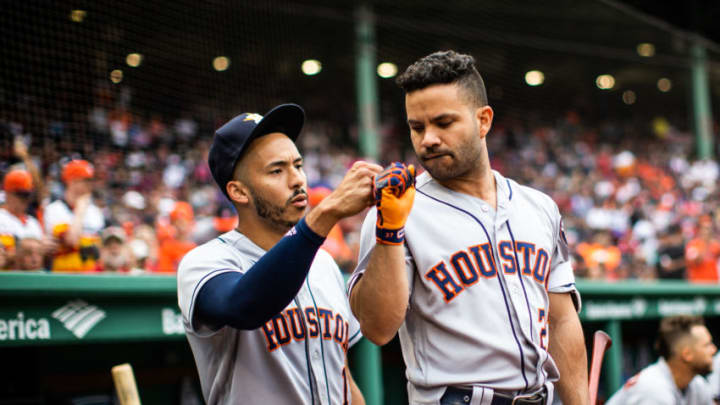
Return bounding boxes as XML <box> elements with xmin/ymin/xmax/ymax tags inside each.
<box><xmin>395</xmin><ymin>51</ymin><xmax>488</xmax><ymax>107</ymax></box>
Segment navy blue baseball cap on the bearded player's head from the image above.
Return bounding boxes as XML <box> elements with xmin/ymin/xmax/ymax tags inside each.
<box><xmin>208</xmin><ymin>104</ymin><xmax>305</xmax><ymax>198</ymax></box>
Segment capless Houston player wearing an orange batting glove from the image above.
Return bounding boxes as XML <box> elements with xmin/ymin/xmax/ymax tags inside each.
<box><xmin>348</xmin><ymin>51</ymin><xmax>588</xmax><ymax>405</ymax></box>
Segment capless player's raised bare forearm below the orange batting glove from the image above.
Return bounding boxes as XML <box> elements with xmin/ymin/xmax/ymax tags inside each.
<box><xmin>350</xmin><ymin>245</ymin><xmax>409</xmax><ymax>346</ymax></box>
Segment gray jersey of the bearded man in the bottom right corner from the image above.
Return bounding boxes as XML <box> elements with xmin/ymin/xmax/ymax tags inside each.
<box><xmin>606</xmin><ymin>358</ymin><xmax>713</xmax><ymax>405</ymax></box>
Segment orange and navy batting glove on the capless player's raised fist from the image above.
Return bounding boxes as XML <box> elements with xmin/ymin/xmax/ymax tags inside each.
<box><xmin>373</xmin><ymin>162</ymin><xmax>415</xmax><ymax>245</ymax></box>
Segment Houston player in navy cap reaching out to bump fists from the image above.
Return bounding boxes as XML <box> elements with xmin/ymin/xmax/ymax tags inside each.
<box><xmin>178</xmin><ymin>104</ymin><xmax>382</xmax><ymax>405</ymax></box>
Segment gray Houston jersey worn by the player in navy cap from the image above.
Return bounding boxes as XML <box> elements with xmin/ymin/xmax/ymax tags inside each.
<box><xmin>177</xmin><ymin>230</ymin><xmax>361</xmax><ymax>405</ymax></box>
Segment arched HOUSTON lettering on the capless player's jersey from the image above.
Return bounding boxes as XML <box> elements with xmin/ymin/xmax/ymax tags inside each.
<box><xmin>425</xmin><ymin>241</ymin><xmax>550</xmax><ymax>302</ymax></box>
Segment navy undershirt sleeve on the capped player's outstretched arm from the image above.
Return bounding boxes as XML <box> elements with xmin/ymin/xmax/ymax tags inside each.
<box><xmin>195</xmin><ymin>218</ymin><xmax>325</xmax><ymax>330</ymax></box>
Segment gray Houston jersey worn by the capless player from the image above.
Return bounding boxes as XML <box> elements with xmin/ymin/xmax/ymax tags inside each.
<box><xmin>349</xmin><ymin>172</ymin><xmax>579</xmax><ymax>404</ymax></box>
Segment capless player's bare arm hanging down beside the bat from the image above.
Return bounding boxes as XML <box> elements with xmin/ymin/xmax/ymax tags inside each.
<box><xmin>549</xmin><ymin>294</ymin><xmax>589</xmax><ymax>405</ymax></box>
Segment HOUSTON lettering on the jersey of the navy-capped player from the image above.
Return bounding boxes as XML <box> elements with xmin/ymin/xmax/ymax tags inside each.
<box><xmin>262</xmin><ymin>307</ymin><xmax>350</xmax><ymax>352</ymax></box>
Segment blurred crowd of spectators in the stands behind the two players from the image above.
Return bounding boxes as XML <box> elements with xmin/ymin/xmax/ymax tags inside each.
<box><xmin>0</xmin><ymin>106</ymin><xmax>720</xmax><ymax>283</ymax></box>
